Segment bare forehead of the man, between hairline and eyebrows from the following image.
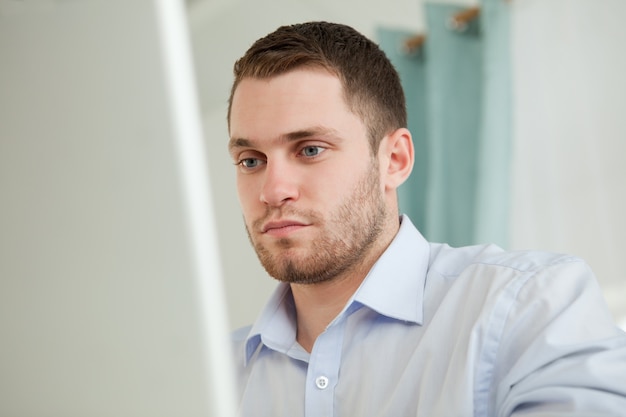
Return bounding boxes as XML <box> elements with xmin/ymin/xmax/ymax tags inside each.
<box><xmin>229</xmin><ymin>68</ymin><xmax>362</xmax><ymax>138</ymax></box>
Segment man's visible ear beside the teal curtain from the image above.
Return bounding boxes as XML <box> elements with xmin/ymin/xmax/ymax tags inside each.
<box><xmin>380</xmin><ymin>128</ymin><xmax>415</xmax><ymax>190</ymax></box>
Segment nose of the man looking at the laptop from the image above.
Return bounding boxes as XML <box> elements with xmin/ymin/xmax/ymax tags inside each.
<box><xmin>260</xmin><ymin>161</ymin><xmax>299</xmax><ymax>207</ymax></box>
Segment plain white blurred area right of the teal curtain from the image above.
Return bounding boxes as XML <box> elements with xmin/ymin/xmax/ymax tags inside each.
<box><xmin>511</xmin><ymin>0</ymin><xmax>626</xmax><ymax>327</ymax></box>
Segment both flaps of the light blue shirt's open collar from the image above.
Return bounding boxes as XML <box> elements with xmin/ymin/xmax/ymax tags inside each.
<box><xmin>244</xmin><ymin>215</ymin><xmax>430</xmax><ymax>364</ymax></box>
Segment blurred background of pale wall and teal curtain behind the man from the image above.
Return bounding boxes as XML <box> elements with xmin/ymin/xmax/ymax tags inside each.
<box><xmin>187</xmin><ymin>0</ymin><xmax>626</xmax><ymax>328</ymax></box>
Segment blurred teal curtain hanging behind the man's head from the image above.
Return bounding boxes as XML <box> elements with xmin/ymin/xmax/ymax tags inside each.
<box><xmin>378</xmin><ymin>0</ymin><xmax>511</xmax><ymax>246</ymax></box>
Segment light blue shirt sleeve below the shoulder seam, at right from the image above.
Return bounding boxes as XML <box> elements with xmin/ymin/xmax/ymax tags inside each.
<box><xmin>489</xmin><ymin>258</ymin><xmax>626</xmax><ymax>416</ymax></box>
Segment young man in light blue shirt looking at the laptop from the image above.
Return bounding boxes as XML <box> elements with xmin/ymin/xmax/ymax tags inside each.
<box><xmin>228</xmin><ymin>22</ymin><xmax>626</xmax><ymax>417</ymax></box>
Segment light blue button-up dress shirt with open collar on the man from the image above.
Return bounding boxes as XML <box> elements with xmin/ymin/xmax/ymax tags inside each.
<box><xmin>233</xmin><ymin>216</ymin><xmax>626</xmax><ymax>417</ymax></box>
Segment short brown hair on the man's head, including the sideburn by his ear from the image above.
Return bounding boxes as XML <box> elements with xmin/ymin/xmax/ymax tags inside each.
<box><xmin>228</xmin><ymin>22</ymin><xmax>407</xmax><ymax>154</ymax></box>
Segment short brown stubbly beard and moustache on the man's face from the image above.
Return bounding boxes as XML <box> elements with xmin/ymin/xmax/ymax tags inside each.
<box><xmin>246</xmin><ymin>161</ymin><xmax>387</xmax><ymax>284</ymax></box>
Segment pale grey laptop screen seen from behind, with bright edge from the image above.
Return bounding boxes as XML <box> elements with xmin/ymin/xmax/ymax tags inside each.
<box><xmin>0</xmin><ymin>0</ymin><xmax>234</xmax><ymax>417</ymax></box>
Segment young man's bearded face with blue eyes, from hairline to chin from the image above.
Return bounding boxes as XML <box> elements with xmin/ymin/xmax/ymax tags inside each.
<box><xmin>229</xmin><ymin>69</ymin><xmax>387</xmax><ymax>283</ymax></box>
